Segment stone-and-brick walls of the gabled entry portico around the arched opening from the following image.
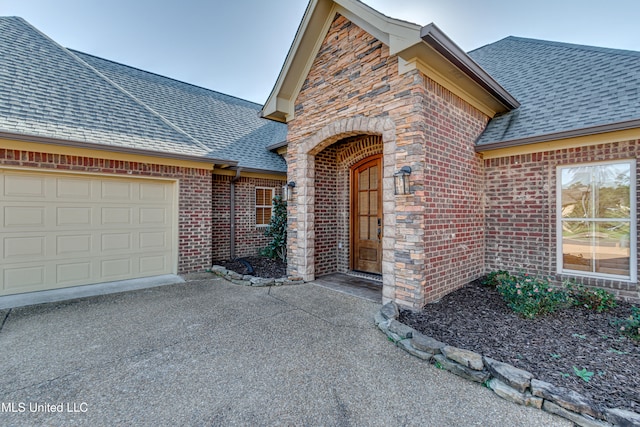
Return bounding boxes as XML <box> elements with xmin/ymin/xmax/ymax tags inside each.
<box><xmin>288</xmin><ymin>15</ymin><xmax>487</xmax><ymax>308</ymax></box>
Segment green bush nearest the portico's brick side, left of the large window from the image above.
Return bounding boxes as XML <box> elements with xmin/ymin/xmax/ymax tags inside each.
<box><xmin>496</xmin><ymin>274</ymin><xmax>570</xmax><ymax>319</ymax></box>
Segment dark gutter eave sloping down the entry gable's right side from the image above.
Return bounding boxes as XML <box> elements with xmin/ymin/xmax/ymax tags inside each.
<box><xmin>420</xmin><ymin>23</ymin><xmax>520</xmax><ymax>110</ymax></box>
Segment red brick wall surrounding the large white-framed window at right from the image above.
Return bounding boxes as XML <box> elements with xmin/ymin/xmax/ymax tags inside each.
<box><xmin>484</xmin><ymin>140</ymin><xmax>640</xmax><ymax>301</ymax></box>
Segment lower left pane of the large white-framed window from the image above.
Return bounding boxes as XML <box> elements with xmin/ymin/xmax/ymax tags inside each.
<box><xmin>562</xmin><ymin>221</ymin><xmax>593</xmax><ymax>272</ymax></box>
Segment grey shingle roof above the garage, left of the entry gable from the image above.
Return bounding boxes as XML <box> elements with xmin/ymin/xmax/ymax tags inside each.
<box><xmin>0</xmin><ymin>17</ymin><xmax>286</xmax><ymax>172</ymax></box>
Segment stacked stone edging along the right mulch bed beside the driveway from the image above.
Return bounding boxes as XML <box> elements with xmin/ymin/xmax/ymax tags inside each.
<box><xmin>374</xmin><ymin>302</ymin><xmax>640</xmax><ymax>427</ymax></box>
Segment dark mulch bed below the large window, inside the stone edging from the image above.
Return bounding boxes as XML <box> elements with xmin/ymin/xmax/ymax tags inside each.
<box><xmin>399</xmin><ymin>282</ymin><xmax>640</xmax><ymax>412</ymax></box>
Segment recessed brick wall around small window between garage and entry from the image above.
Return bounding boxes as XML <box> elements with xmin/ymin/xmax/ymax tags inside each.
<box><xmin>212</xmin><ymin>175</ymin><xmax>286</xmax><ymax>260</ymax></box>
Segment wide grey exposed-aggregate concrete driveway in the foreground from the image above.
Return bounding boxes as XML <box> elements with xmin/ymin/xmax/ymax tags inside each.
<box><xmin>0</xmin><ymin>279</ymin><xmax>571</xmax><ymax>426</ymax></box>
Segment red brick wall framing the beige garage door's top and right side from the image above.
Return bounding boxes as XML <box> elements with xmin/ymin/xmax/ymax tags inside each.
<box><xmin>0</xmin><ymin>149</ymin><xmax>212</xmax><ymax>274</ymax></box>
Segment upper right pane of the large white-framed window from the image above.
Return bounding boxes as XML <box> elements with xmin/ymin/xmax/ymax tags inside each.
<box><xmin>594</xmin><ymin>164</ymin><xmax>631</xmax><ymax>218</ymax></box>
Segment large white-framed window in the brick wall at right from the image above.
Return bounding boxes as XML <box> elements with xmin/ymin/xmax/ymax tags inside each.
<box><xmin>557</xmin><ymin>160</ymin><xmax>637</xmax><ymax>281</ymax></box>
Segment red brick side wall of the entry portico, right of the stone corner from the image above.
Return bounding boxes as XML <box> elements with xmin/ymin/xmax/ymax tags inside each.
<box><xmin>424</xmin><ymin>79</ymin><xmax>488</xmax><ymax>301</ymax></box>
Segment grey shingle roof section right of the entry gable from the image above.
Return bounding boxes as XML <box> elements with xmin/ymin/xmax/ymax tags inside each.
<box><xmin>469</xmin><ymin>37</ymin><xmax>640</xmax><ymax>146</ymax></box>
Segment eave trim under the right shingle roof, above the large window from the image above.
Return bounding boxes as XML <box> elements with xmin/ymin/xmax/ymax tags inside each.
<box><xmin>475</xmin><ymin>119</ymin><xmax>640</xmax><ymax>153</ymax></box>
